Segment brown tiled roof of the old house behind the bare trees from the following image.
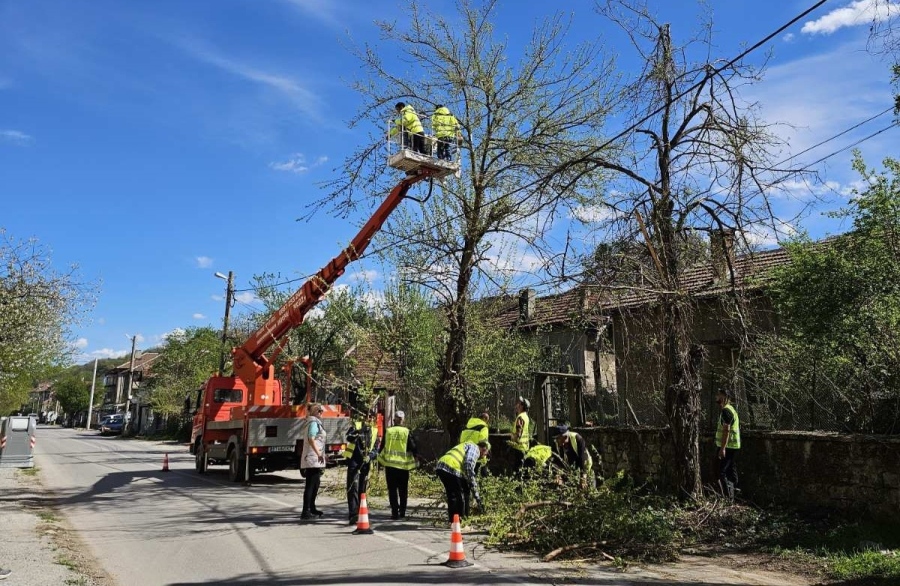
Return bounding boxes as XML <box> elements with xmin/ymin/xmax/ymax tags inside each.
<box><xmin>495</xmin><ymin>248</ymin><xmax>789</xmax><ymax>328</ymax></box>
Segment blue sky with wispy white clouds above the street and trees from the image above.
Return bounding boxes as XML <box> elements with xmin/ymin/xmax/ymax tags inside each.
<box><xmin>0</xmin><ymin>0</ymin><xmax>900</xmax><ymax>362</ymax></box>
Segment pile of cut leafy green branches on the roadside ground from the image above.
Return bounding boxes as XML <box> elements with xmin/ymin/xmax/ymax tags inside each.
<box><xmin>473</xmin><ymin>473</ymin><xmax>680</xmax><ymax>560</ymax></box>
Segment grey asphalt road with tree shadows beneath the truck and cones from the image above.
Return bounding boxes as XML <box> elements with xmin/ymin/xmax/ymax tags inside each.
<box><xmin>29</xmin><ymin>427</ymin><xmax>803</xmax><ymax>586</ymax></box>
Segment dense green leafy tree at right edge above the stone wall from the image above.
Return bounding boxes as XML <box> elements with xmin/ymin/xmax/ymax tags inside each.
<box><xmin>748</xmin><ymin>154</ymin><xmax>900</xmax><ymax>433</ymax></box>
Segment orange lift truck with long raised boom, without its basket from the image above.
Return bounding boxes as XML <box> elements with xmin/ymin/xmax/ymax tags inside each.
<box><xmin>188</xmin><ymin>155</ymin><xmax>459</xmax><ymax>482</ymax></box>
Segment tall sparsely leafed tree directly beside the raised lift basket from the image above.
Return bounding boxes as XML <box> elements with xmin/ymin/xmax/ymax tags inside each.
<box><xmin>318</xmin><ymin>0</ymin><xmax>613</xmax><ymax>431</ymax></box>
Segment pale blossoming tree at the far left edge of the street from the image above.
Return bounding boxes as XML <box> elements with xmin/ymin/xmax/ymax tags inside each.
<box><xmin>0</xmin><ymin>228</ymin><xmax>95</xmax><ymax>413</ymax></box>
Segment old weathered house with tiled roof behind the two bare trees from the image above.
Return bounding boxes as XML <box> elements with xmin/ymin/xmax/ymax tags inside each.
<box><xmin>499</xmin><ymin>237</ymin><xmax>788</xmax><ymax>425</ymax></box>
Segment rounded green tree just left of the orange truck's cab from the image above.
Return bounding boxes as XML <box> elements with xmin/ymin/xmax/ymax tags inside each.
<box><xmin>147</xmin><ymin>327</ymin><xmax>222</xmax><ymax>416</ymax></box>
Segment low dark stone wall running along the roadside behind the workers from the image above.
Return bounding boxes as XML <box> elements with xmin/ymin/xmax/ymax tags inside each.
<box><xmin>416</xmin><ymin>427</ymin><xmax>900</xmax><ymax>522</ymax></box>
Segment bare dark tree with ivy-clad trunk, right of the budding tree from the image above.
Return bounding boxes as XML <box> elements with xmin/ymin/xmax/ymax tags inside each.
<box><xmin>573</xmin><ymin>0</ymin><xmax>808</xmax><ymax>497</ymax></box>
